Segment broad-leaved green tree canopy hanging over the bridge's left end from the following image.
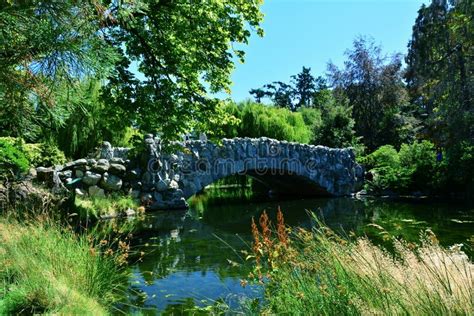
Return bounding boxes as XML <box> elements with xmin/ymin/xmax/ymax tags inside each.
<box><xmin>104</xmin><ymin>0</ymin><xmax>263</xmax><ymax>140</ymax></box>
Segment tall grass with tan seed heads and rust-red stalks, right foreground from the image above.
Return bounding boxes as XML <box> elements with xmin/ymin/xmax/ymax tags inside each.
<box><xmin>248</xmin><ymin>209</ymin><xmax>474</xmax><ymax>315</ymax></box>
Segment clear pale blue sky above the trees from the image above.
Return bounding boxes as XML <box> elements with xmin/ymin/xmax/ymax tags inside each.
<box><xmin>226</xmin><ymin>0</ymin><xmax>428</xmax><ymax>101</ymax></box>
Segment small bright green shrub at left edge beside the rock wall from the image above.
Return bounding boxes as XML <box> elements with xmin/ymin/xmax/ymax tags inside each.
<box><xmin>0</xmin><ymin>138</ymin><xmax>30</xmax><ymax>176</ymax></box>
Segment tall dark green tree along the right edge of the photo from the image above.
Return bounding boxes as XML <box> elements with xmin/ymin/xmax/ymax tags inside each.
<box><xmin>406</xmin><ymin>0</ymin><xmax>474</xmax><ymax>193</ymax></box>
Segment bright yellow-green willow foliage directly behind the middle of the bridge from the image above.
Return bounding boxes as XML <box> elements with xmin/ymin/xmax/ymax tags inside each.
<box><xmin>227</xmin><ymin>102</ymin><xmax>311</xmax><ymax>143</ymax></box>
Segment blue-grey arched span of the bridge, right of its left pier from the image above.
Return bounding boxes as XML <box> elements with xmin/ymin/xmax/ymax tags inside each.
<box><xmin>171</xmin><ymin>138</ymin><xmax>360</xmax><ymax>199</ymax></box>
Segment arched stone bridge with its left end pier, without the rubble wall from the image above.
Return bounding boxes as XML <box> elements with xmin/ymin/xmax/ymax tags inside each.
<box><xmin>133</xmin><ymin>136</ymin><xmax>362</xmax><ymax>208</ymax></box>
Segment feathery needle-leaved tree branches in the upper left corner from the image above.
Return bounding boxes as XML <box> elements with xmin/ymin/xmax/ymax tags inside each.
<box><xmin>0</xmin><ymin>1</ymin><xmax>115</xmax><ymax>140</ymax></box>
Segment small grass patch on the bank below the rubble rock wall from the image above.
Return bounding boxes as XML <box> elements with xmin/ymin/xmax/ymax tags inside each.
<box><xmin>74</xmin><ymin>195</ymin><xmax>143</xmax><ymax>219</ymax></box>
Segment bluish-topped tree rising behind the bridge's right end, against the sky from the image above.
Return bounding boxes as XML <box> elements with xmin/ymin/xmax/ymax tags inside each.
<box><xmin>329</xmin><ymin>37</ymin><xmax>407</xmax><ymax>150</ymax></box>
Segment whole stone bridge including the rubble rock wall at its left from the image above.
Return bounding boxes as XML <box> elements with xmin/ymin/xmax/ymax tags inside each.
<box><xmin>44</xmin><ymin>135</ymin><xmax>362</xmax><ymax>209</ymax></box>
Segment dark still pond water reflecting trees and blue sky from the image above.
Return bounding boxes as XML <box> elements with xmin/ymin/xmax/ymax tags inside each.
<box><xmin>119</xmin><ymin>188</ymin><xmax>474</xmax><ymax>314</ymax></box>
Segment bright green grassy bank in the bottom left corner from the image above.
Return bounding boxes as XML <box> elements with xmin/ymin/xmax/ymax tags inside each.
<box><xmin>0</xmin><ymin>219</ymin><xmax>128</xmax><ymax>315</ymax></box>
